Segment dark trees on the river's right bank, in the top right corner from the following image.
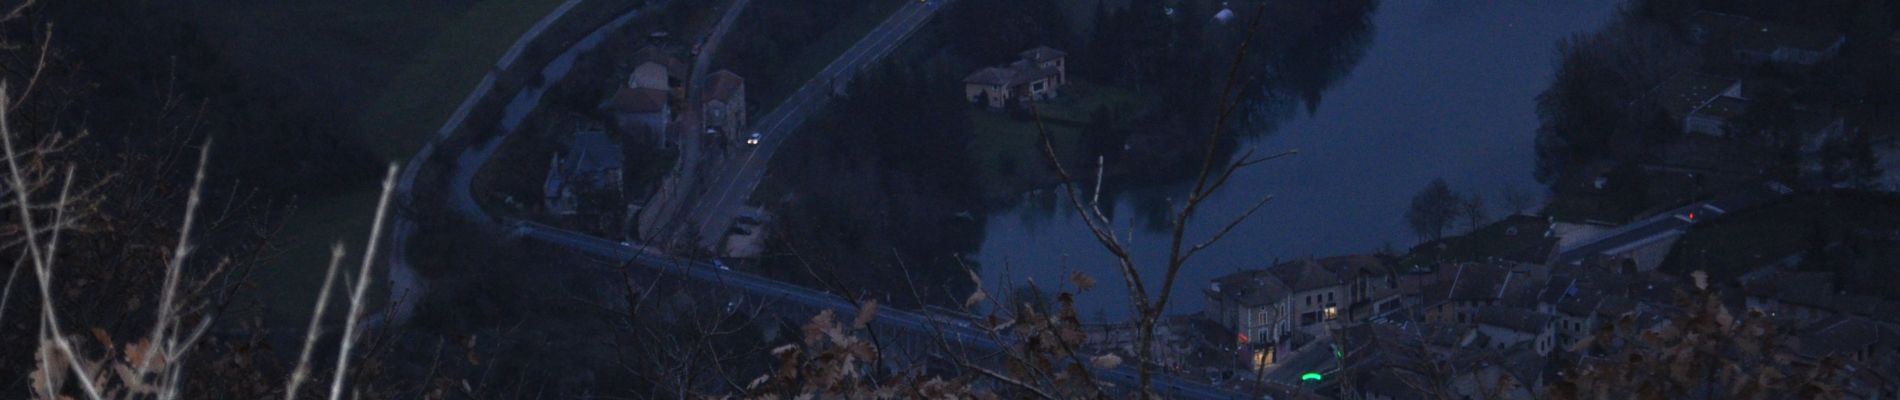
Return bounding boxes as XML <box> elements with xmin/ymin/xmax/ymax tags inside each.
<box><xmin>1535</xmin><ymin>0</ymin><xmax>1900</xmax><ymax>184</ymax></box>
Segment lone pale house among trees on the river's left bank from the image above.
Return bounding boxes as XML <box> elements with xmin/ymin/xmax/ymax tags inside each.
<box><xmin>963</xmin><ymin>45</ymin><xmax>1068</xmax><ymax>108</ymax></box>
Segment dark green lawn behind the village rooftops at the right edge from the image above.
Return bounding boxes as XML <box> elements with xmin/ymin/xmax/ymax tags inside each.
<box><xmin>1663</xmin><ymin>193</ymin><xmax>1900</xmax><ymax>286</ymax></box>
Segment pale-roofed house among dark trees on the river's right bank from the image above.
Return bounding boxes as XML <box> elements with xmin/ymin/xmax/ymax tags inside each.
<box><xmin>1651</xmin><ymin>74</ymin><xmax>1748</xmax><ymax>136</ymax></box>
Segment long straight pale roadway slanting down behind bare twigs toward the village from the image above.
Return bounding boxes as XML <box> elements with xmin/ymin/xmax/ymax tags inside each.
<box><xmin>509</xmin><ymin>220</ymin><xmax>1248</xmax><ymax>400</ymax></box>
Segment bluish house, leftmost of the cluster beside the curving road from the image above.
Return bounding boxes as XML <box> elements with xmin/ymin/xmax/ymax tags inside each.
<box><xmin>542</xmin><ymin>131</ymin><xmax>625</xmax><ymax>216</ymax></box>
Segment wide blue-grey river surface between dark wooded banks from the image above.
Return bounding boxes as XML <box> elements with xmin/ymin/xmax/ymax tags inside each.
<box><xmin>979</xmin><ymin>0</ymin><xmax>1615</xmax><ymax>317</ymax></box>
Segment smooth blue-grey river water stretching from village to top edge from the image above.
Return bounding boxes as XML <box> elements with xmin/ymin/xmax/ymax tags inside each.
<box><xmin>979</xmin><ymin>0</ymin><xmax>1619</xmax><ymax>320</ymax></box>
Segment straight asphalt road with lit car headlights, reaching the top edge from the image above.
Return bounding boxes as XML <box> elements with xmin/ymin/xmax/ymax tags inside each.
<box><xmin>686</xmin><ymin>0</ymin><xmax>952</xmax><ymax>248</ymax></box>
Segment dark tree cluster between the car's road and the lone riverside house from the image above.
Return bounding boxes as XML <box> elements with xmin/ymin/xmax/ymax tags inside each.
<box><xmin>768</xmin><ymin>64</ymin><xmax>982</xmax><ymax>305</ymax></box>
